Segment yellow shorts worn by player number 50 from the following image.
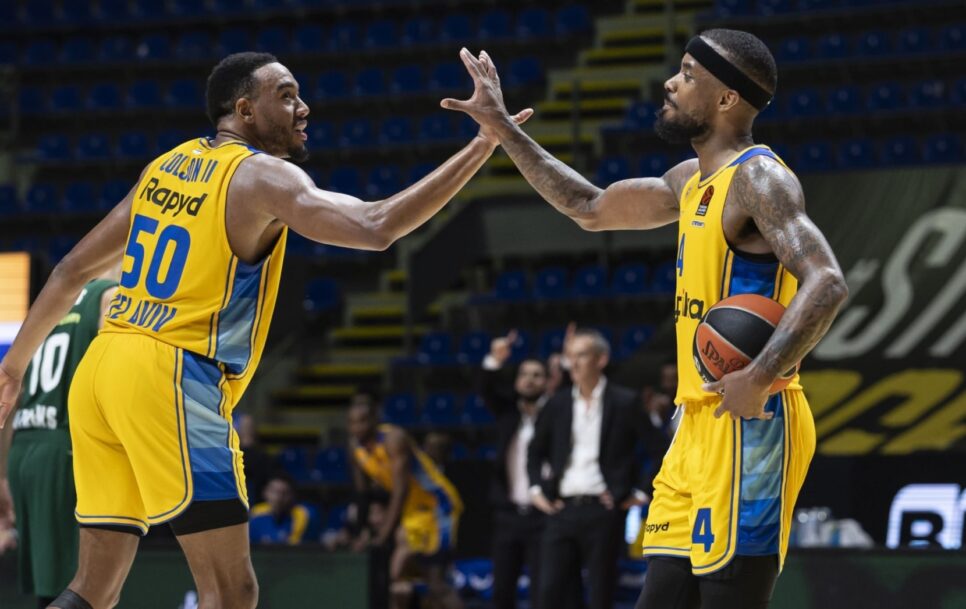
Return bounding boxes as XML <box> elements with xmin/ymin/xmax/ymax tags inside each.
<box><xmin>69</xmin><ymin>333</ymin><xmax>248</xmax><ymax>532</ymax></box>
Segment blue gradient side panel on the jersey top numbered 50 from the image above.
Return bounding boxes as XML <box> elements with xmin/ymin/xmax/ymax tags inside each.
<box><xmin>215</xmin><ymin>261</ymin><xmax>264</xmax><ymax>374</ymax></box>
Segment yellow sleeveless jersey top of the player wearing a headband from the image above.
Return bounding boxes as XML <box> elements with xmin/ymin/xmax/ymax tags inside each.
<box><xmin>674</xmin><ymin>146</ymin><xmax>801</xmax><ymax>404</ymax></box>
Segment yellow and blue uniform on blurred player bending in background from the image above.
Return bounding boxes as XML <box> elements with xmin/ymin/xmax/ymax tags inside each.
<box><xmin>354</xmin><ymin>425</ymin><xmax>463</xmax><ymax>554</ymax></box>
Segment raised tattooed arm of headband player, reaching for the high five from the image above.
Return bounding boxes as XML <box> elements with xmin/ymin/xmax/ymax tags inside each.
<box><xmin>442</xmin><ymin>49</ymin><xmax>698</xmax><ymax>231</ymax></box>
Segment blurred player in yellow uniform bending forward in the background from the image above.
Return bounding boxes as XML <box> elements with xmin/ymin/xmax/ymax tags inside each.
<box><xmin>349</xmin><ymin>403</ymin><xmax>463</xmax><ymax>609</ymax></box>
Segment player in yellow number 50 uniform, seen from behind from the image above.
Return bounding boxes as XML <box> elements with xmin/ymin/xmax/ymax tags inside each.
<box><xmin>0</xmin><ymin>53</ymin><xmax>531</xmax><ymax>609</ymax></box>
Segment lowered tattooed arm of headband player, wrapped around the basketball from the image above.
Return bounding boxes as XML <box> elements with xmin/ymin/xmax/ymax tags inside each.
<box><xmin>705</xmin><ymin>157</ymin><xmax>848</xmax><ymax>416</ymax></box>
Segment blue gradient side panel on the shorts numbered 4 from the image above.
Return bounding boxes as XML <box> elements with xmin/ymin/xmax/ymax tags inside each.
<box><xmin>737</xmin><ymin>393</ymin><xmax>785</xmax><ymax>556</ymax></box>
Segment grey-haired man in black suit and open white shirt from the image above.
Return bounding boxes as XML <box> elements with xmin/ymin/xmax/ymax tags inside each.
<box><xmin>527</xmin><ymin>329</ymin><xmax>667</xmax><ymax>609</ymax></box>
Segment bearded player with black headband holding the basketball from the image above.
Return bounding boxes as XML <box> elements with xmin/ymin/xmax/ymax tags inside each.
<box><xmin>443</xmin><ymin>29</ymin><xmax>847</xmax><ymax>609</ymax></box>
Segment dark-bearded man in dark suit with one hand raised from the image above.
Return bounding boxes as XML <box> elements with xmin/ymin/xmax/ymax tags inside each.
<box><xmin>480</xmin><ymin>331</ymin><xmax>547</xmax><ymax>609</ymax></box>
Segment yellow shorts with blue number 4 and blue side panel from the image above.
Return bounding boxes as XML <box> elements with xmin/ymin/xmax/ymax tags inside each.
<box><xmin>643</xmin><ymin>390</ymin><xmax>815</xmax><ymax>575</ymax></box>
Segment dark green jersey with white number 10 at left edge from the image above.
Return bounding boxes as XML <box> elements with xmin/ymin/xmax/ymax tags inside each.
<box><xmin>13</xmin><ymin>279</ymin><xmax>117</xmax><ymax>430</ymax></box>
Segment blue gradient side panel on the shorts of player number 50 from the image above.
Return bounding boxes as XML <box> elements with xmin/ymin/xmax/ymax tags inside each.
<box><xmin>181</xmin><ymin>351</ymin><xmax>238</xmax><ymax>501</ymax></box>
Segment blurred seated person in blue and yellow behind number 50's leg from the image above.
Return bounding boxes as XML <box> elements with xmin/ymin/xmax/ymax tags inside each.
<box><xmin>248</xmin><ymin>473</ymin><xmax>320</xmax><ymax>546</ymax></box>
